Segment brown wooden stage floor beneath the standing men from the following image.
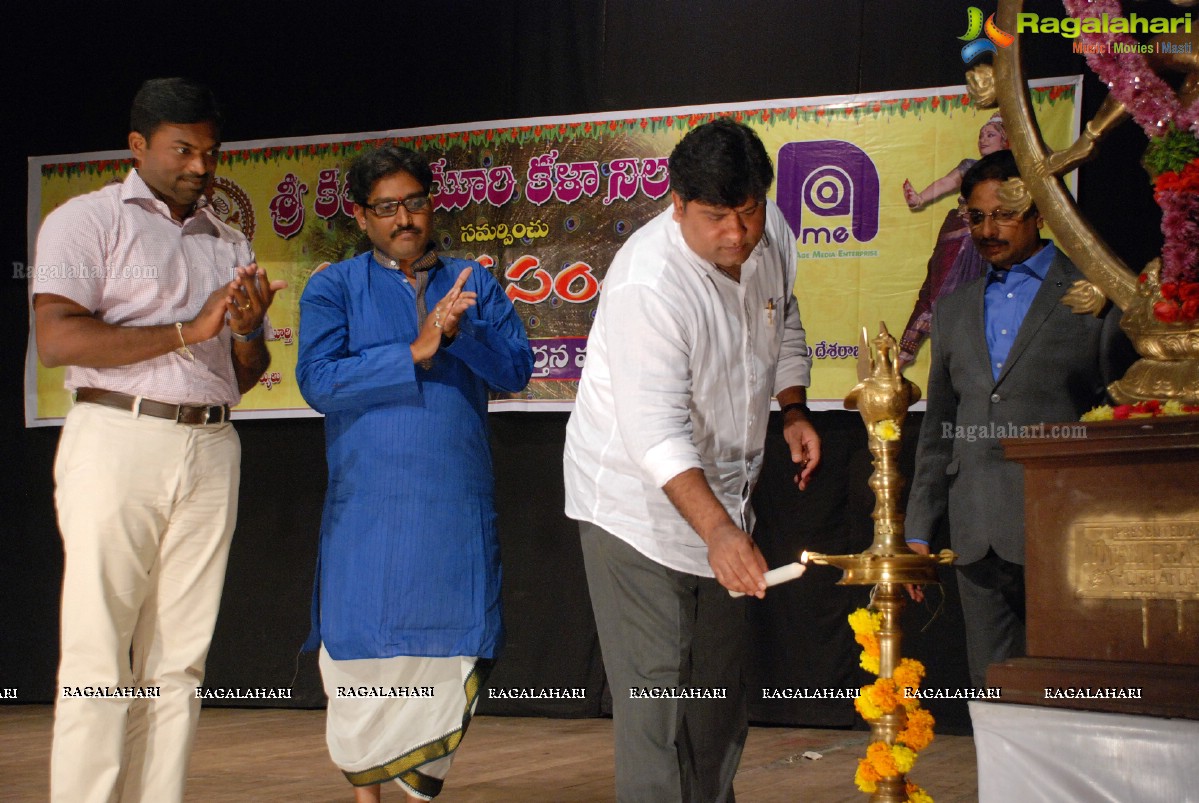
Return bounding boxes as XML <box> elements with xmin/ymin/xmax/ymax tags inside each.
<box><xmin>0</xmin><ymin>705</ymin><xmax>977</xmax><ymax>803</ymax></box>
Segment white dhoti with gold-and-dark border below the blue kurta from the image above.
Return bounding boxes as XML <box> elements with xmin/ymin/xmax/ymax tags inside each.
<box><xmin>320</xmin><ymin>645</ymin><xmax>490</xmax><ymax>801</ymax></box>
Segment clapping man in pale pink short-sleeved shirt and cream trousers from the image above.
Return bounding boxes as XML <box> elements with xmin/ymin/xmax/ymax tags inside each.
<box><xmin>34</xmin><ymin>78</ymin><xmax>287</xmax><ymax>803</ymax></box>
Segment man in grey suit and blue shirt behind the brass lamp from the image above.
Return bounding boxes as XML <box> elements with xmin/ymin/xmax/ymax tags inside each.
<box><xmin>906</xmin><ymin>151</ymin><xmax>1134</xmax><ymax>688</ymax></box>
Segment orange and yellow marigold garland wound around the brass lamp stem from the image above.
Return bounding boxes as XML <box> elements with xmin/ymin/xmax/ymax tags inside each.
<box><xmin>849</xmin><ymin>608</ymin><xmax>935</xmax><ymax>803</ymax></box>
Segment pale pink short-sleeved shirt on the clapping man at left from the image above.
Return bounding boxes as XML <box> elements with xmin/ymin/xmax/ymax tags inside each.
<box><xmin>32</xmin><ymin>170</ymin><xmax>254</xmax><ymax>405</ymax></box>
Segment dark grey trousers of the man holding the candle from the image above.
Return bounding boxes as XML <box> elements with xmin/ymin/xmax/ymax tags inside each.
<box><xmin>579</xmin><ymin>521</ymin><xmax>748</xmax><ymax>803</ymax></box>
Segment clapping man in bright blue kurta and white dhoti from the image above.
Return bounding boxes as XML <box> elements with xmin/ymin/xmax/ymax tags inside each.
<box><xmin>296</xmin><ymin>146</ymin><xmax>532</xmax><ymax>801</ymax></box>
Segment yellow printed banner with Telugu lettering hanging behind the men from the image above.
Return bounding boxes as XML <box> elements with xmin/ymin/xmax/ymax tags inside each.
<box><xmin>23</xmin><ymin>77</ymin><xmax>1081</xmax><ymax>425</ymax></box>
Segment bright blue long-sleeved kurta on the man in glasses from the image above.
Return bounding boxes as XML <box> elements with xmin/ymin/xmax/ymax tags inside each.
<box><xmin>296</xmin><ymin>253</ymin><xmax>532</xmax><ymax>660</ymax></box>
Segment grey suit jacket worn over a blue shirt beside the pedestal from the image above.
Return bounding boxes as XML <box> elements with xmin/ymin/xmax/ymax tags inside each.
<box><xmin>905</xmin><ymin>246</ymin><xmax>1135</xmax><ymax>564</ymax></box>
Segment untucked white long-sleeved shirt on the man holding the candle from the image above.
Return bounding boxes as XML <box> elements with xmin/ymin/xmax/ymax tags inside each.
<box><xmin>564</xmin><ymin>203</ymin><xmax>812</xmax><ymax>576</ymax></box>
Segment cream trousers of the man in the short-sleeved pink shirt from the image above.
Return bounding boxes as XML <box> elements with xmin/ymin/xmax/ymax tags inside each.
<box><xmin>50</xmin><ymin>404</ymin><xmax>241</xmax><ymax>803</ymax></box>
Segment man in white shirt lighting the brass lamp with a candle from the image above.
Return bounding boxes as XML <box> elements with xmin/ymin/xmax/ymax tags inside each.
<box><xmin>565</xmin><ymin>120</ymin><xmax>820</xmax><ymax>802</ymax></box>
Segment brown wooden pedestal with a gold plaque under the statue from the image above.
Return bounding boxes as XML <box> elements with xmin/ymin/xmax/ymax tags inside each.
<box><xmin>987</xmin><ymin>416</ymin><xmax>1199</xmax><ymax>719</ymax></box>
